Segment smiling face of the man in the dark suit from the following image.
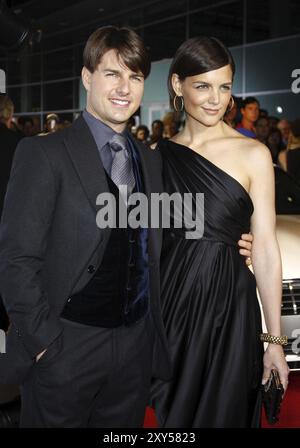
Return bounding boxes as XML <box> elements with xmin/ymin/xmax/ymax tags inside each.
<box><xmin>82</xmin><ymin>50</ymin><xmax>144</xmax><ymax>132</ymax></box>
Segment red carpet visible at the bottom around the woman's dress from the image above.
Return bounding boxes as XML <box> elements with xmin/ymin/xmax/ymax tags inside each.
<box><xmin>144</xmin><ymin>372</ymin><xmax>300</xmax><ymax>428</ymax></box>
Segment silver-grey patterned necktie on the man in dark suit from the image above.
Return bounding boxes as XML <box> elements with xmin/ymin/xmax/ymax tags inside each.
<box><xmin>108</xmin><ymin>134</ymin><xmax>135</xmax><ymax>203</ymax></box>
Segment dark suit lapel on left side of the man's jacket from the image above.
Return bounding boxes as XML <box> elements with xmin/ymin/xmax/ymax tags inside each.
<box><xmin>65</xmin><ymin>117</ymin><xmax>109</xmax><ymax>211</ymax></box>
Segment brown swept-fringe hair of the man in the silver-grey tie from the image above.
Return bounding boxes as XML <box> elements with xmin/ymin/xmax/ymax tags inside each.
<box><xmin>83</xmin><ymin>26</ymin><xmax>151</xmax><ymax>78</ymax></box>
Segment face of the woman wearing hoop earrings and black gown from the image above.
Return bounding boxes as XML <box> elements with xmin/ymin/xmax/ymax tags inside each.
<box><xmin>172</xmin><ymin>65</ymin><xmax>232</xmax><ymax>126</ymax></box>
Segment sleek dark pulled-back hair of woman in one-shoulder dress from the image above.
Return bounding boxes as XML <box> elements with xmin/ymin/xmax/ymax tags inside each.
<box><xmin>168</xmin><ymin>36</ymin><xmax>235</xmax><ymax>104</ymax></box>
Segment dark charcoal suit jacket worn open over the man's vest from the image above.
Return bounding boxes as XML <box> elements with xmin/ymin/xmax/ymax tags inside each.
<box><xmin>0</xmin><ymin>117</ymin><xmax>170</xmax><ymax>383</ymax></box>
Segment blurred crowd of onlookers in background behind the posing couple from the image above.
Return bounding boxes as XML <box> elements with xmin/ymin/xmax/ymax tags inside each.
<box><xmin>0</xmin><ymin>95</ymin><xmax>300</xmax><ymax>184</ymax></box>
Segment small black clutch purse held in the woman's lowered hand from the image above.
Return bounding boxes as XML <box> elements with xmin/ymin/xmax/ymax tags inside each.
<box><xmin>262</xmin><ymin>370</ymin><xmax>284</xmax><ymax>424</ymax></box>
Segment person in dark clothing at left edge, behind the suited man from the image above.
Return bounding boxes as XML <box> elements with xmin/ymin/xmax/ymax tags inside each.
<box><xmin>0</xmin><ymin>94</ymin><xmax>21</xmax><ymax>331</ymax></box>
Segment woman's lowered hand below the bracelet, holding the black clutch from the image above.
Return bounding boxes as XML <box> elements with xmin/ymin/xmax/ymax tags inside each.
<box><xmin>262</xmin><ymin>344</ymin><xmax>290</xmax><ymax>393</ymax></box>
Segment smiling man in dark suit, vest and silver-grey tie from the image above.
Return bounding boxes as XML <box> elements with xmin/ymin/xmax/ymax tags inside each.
<box><xmin>0</xmin><ymin>27</ymin><xmax>253</xmax><ymax>427</ymax></box>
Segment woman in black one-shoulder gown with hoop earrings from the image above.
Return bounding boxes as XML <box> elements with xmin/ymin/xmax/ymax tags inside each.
<box><xmin>152</xmin><ymin>37</ymin><xmax>289</xmax><ymax>428</ymax></box>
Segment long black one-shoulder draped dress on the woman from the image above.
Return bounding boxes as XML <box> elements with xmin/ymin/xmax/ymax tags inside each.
<box><xmin>152</xmin><ymin>140</ymin><xmax>263</xmax><ymax>428</ymax></box>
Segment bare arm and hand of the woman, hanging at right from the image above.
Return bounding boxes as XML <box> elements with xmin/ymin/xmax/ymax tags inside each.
<box><xmin>249</xmin><ymin>143</ymin><xmax>289</xmax><ymax>389</ymax></box>
